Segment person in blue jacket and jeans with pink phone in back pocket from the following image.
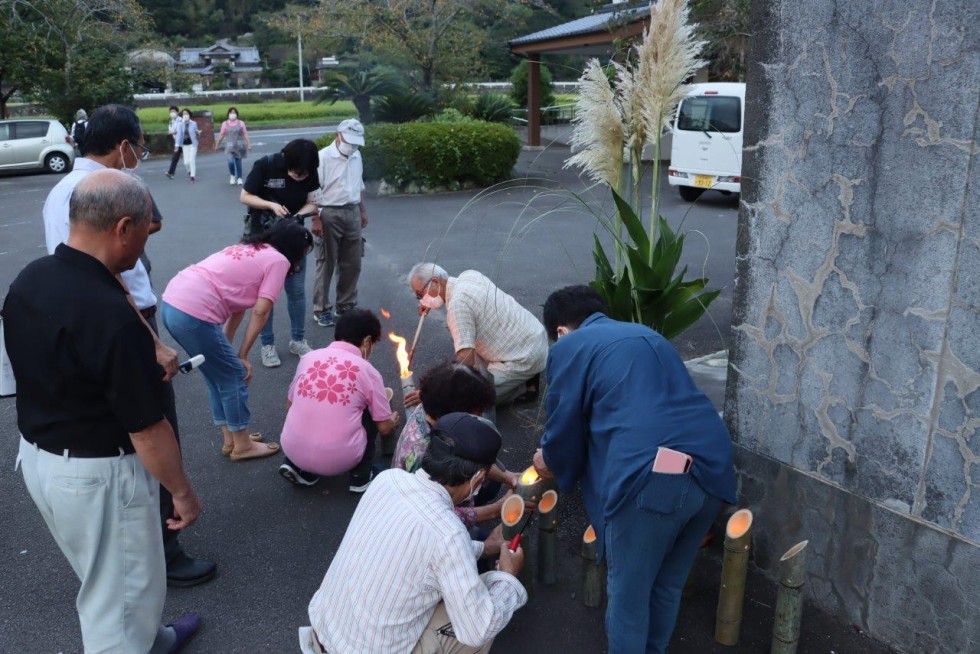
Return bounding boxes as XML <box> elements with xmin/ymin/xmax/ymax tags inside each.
<box><xmin>534</xmin><ymin>286</ymin><xmax>735</xmax><ymax>654</ymax></box>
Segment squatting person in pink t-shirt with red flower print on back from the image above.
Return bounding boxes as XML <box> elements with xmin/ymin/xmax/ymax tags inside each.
<box><xmin>279</xmin><ymin>309</ymin><xmax>399</xmax><ymax>493</ymax></box>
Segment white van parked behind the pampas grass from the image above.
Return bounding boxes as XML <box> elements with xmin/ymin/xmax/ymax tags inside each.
<box><xmin>667</xmin><ymin>82</ymin><xmax>745</xmax><ymax>202</ymax></box>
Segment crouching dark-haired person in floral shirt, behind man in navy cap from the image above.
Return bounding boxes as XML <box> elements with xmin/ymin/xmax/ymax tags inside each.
<box><xmin>391</xmin><ymin>361</ymin><xmax>518</xmax><ymax>527</ymax></box>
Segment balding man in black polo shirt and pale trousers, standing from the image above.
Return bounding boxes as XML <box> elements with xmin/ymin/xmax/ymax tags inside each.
<box><xmin>3</xmin><ymin>169</ymin><xmax>201</xmax><ymax>654</ymax></box>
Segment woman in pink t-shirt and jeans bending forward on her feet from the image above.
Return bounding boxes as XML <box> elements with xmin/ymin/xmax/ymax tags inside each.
<box><xmin>160</xmin><ymin>220</ymin><xmax>313</xmax><ymax>461</ymax></box>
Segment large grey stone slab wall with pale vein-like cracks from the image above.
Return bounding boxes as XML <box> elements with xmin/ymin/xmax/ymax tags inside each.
<box><xmin>725</xmin><ymin>0</ymin><xmax>980</xmax><ymax>652</ymax></box>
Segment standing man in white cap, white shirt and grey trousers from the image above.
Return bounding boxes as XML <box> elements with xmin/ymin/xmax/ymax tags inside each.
<box><xmin>311</xmin><ymin>118</ymin><xmax>367</xmax><ymax>327</ymax></box>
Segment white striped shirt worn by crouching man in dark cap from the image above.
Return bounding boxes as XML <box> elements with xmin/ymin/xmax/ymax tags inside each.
<box><xmin>309</xmin><ymin>470</ymin><xmax>527</xmax><ymax>654</ymax></box>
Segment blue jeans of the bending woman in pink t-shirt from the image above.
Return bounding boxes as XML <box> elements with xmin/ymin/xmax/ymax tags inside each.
<box><xmin>160</xmin><ymin>302</ymin><xmax>252</xmax><ymax>431</ymax></box>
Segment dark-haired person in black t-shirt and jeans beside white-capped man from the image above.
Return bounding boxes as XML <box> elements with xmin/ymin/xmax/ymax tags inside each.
<box><xmin>241</xmin><ymin>139</ymin><xmax>320</xmax><ymax>368</ymax></box>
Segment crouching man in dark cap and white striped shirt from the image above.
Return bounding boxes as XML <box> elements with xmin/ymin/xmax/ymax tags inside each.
<box><xmin>299</xmin><ymin>413</ymin><xmax>527</xmax><ymax>654</ymax></box>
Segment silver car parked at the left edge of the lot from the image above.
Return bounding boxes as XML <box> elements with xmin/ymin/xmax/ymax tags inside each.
<box><xmin>0</xmin><ymin>119</ymin><xmax>75</xmax><ymax>173</ymax></box>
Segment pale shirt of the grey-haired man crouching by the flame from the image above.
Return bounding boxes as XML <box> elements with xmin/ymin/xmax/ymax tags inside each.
<box><xmin>446</xmin><ymin>270</ymin><xmax>548</xmax><ymax>378</ymax></box>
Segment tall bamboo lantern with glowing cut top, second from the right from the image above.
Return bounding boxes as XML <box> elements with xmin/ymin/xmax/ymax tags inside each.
<box><xmin>715</xmin><ymin>509</ymin><xmax>752</xmax><ymax>646</ymax></box>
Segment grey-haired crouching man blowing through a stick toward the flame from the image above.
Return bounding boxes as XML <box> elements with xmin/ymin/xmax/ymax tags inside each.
<box><xmin>405</xmin><ymin>262</ymin><xmax>548</xmax><ymax>406</ymax></box>
